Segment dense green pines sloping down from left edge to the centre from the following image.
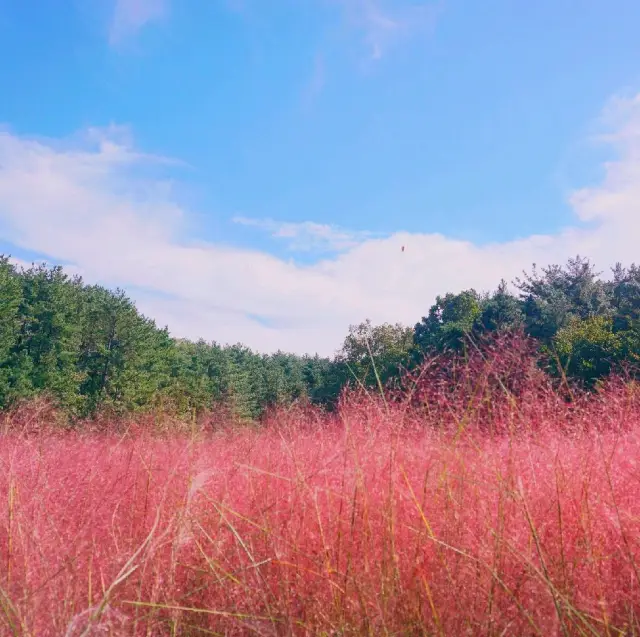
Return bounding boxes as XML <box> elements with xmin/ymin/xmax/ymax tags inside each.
<box><xmin>0</xmin><ymin>257</ymin><xmax>340</xmax><ymax>419</ymax></box>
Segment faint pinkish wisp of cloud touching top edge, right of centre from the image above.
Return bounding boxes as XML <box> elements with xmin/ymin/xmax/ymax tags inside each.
<box><xmin>334</xmin><ymin>0</ymin><xmax>441</xmax><ymax>60</ymax></box>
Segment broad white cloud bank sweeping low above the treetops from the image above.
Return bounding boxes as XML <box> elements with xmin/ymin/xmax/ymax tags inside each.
<box><xmin>0</xmin><ymin>92</ymin><xmax>640</xmax><ymax>353</ymax></box>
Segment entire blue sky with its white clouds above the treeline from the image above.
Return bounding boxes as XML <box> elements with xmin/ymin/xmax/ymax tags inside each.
<box><xmin>0</xmin><ymin>0</ymin><xmax>640</xmax><ymax>353</ymax></box>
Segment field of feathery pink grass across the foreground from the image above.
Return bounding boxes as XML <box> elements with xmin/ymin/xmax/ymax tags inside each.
<box><xmin>0</xmin><ymin>342</ymin><xmax>640</xmax><ymax>637</ymax></box>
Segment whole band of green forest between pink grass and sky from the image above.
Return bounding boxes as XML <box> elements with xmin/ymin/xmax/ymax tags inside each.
<box><xmin>0</xmin><ymin>256</ymin><xmax>640</xmax><ymax>419</ymax></box>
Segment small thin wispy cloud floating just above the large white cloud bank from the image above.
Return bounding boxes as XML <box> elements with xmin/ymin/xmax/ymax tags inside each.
<box><xmin>233</xmin><ymin>217</ymin><xmax>373</xmax><ymax>252</ymax></box>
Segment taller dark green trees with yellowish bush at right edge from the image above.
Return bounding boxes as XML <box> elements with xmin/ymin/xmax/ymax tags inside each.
<box><xmin>414</xmin><ymin>256</ymin><xmax>640</xmax><ymax>384</ymax></box>
